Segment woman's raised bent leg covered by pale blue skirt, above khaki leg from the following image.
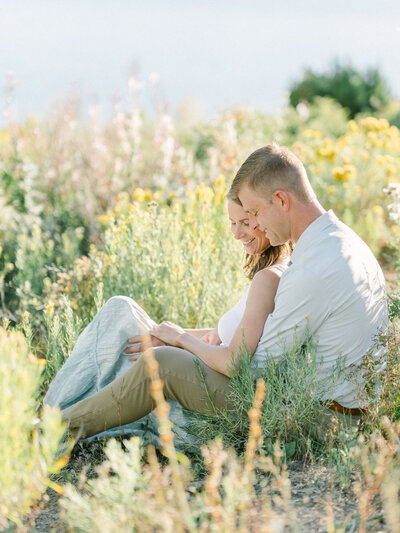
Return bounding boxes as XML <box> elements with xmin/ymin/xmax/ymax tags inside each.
<box><xmin>44</xmin><ymin>296</ymin><xmax>154</xmax><ymax>409</ymax></box>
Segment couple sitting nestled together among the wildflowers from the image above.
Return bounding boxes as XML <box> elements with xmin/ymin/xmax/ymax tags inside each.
<box><xmin>45</xmin><ymin>144</ymin><xmax>388</xmax><ymax>438</ymax></box>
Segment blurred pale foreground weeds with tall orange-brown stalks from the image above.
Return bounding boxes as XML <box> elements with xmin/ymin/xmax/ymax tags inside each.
<box><xmin>57</xmin><ymin>338</ymin><xmax>400</xmax><ymax>532</ymax></box>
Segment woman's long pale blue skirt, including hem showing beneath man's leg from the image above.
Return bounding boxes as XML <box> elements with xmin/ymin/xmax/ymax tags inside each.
<box><xmin>44</xmin><ymin>296</ymin><xmax>227</xmax><ymax>444</ymax></box>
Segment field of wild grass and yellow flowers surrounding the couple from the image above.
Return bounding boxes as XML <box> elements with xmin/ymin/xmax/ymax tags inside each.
<box><xmin>0</xmin><ymin>90</ymin><xmax>400</xmax><ymax>532</ymax></box>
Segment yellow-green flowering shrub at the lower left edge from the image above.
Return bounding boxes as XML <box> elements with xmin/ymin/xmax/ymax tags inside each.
<box><xmin>0</xmin><ymin>328</ymin><xmax>67</xmax><ymax>528</ymax></box>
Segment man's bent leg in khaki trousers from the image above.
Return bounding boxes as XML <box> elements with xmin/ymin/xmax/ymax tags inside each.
<box><xmin>62</xmin><ymin>346</ymin><xmax>230</xmax><ymax>438</ymax></box>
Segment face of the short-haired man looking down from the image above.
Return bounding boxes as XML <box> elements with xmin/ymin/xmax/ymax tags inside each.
<box><xmin>238</xmin><ymin>185</ymin><xmax>290</xmax><ymax>246</ymax></box>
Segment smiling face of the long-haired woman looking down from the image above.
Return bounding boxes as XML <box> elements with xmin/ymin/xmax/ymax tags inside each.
<box><xmin>228</xmin><ymin>200</ymin><xmax>270</xmax><ymax>255</ymax></box>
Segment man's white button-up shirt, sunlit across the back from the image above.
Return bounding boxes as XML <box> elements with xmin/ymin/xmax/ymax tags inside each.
<box><xmin>252</xmin><ymin>211</ymin><xmax>388</xmax><ymax>407</ymax></box>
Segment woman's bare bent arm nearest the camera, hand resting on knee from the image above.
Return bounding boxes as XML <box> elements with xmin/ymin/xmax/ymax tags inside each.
<box><xmin>151</xmin><ymin>269</ymin><xmax>281</xmax><ymax>376</ymax></box>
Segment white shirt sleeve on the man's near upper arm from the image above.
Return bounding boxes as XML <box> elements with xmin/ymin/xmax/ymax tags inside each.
<box><xmin>256</xmin><ymin>265</ymin><xmax>330</xmax><ymax>361</ymax></box>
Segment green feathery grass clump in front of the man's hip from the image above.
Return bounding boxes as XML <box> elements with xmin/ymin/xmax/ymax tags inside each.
<box><xmin>186</xmin><ymin>341</ymin><xmax>346</xmax><ymax>459</ymax></box>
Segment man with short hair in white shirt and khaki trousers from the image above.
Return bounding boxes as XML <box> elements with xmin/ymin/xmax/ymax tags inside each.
<box><xmin>62</xmin><ymin>144</ymin><xmax>387</xmax><ymax>437</ymax></box>
